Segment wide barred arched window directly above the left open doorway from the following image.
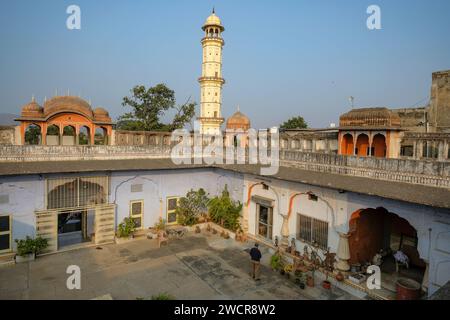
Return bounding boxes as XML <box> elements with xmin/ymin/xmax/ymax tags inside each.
<box><xmin>47</xmin><ymin>176</ymin><xmax>109</xmax><ymax>209</ymax></box>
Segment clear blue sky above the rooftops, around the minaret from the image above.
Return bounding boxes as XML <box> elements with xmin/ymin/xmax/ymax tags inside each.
<box><xmin>0</xmin><ymin>0</ymin><xmax>450</xmax><ymax>128</ymax></box>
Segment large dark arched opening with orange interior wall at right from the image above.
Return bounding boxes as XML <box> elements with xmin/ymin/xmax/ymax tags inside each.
<box><xmin>348</xmin><ymin>207</ymin><xmax>426</xmax><ymax>292</ymax></box>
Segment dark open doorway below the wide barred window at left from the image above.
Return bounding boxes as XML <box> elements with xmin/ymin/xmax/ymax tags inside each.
<box><xmin>58</xmin><ymin>210</ymin><xmax>94</xmax><ymax>249</ymax></box>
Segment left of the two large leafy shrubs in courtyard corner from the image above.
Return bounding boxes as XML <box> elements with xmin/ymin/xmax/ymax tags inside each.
<box><xmin>175</xmin><ymin>188</ymin><xmax>209</xmax><ymax>226</ymax></box>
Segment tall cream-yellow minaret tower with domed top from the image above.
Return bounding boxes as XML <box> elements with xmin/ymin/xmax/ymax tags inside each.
<box><xmin>198</xmin><ymin>9</ymin><xmax>225</xmax><ymax>134</ymax></box>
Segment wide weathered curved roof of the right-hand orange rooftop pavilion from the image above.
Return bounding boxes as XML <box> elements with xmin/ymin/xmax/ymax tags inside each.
<box><xmin>339</xmin><ymin>108</ymin><xmax>400</xmax><ymax>127</ymax></box>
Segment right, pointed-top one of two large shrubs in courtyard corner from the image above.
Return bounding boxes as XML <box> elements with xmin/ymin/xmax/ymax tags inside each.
<box><xmin>208</xmin><ymin>185</ymin><xmax>242</xmax><ymax>231</ymax></box>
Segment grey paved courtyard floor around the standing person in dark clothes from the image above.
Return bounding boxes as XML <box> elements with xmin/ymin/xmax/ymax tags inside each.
<box><xmin>0</xmin><ymin>233</ymin><xmax>354</xmax><ymax>300</ymax></box>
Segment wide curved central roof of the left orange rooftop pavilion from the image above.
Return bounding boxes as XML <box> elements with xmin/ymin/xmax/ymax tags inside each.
<box><xmin>44</xmin><ymin>96</ymin><xmax>94</xmax><ymax>119</ymax></box>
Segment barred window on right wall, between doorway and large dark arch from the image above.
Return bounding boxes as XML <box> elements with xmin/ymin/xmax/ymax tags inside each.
<box><xmin>297</xmin><ymin>214</ymin><xmax>328</xmax><ymax>250</ymax></box>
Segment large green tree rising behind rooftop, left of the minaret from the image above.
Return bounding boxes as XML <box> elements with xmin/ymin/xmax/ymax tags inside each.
<box><xmin>117</xmin><ymin>83</ymin><xmax>196</xmax><ymax>131</ymax></box>
